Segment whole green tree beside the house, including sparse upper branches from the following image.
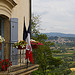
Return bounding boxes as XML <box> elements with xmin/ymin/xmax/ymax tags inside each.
<box><xmin>31</xmin><ymin>16</ymin><xmax>62</xmax><ymax>75</ymax></box>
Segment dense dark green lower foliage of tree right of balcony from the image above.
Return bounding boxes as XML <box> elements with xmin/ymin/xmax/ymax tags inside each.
<box><xmin>33</xmin><ymin>41</ymin><xmax>62</xmax><ymax>75</ymax></box>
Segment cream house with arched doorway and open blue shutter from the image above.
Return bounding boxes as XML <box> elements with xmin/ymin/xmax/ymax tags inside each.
<box><xmin>0</xmin><ymin>0</ymin><xmax>38</xmax><ymax>74</ymax></box>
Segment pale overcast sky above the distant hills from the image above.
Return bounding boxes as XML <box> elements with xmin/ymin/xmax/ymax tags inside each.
<box><xmin>32</xmin><ymin>0</ymin><xmax>75</xmax><ymax>34</ymax></box>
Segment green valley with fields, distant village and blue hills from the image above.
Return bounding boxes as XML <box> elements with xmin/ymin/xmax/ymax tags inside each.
<box><xmin>45</xmin><ymin>33</ymin><xmax>75</xmax><ymax>75</ymax></box>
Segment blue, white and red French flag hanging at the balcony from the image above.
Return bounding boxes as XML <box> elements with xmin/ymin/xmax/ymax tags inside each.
<box><xmin>23</xmin><ymin>19</ymin><xmax>33</xmax><ymax>64</ymax></box>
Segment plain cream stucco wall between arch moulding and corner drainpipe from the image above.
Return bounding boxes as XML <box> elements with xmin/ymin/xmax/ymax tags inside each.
<box><xmin>11</xmin><ymin>0</ymin><xmax>30</xmax><ymax>40</ymax></box>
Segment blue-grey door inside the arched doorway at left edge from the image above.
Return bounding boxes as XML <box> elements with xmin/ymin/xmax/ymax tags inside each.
<box><xmin>0</xmin><ymin>17</ymin><xmax>4</xmax><ymax>60</ymax></box>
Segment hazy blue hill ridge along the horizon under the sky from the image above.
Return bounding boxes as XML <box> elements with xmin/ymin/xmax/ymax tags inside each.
<box><xmin>44</xmin><ymin>32</ymin><xmax>75</xmax><ymax>37</ymax></box>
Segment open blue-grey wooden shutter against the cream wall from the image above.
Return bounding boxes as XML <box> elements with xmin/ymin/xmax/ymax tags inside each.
<box><xmin>10</xmin><ymin>18</ymin><xmax>18</xmax><ymax>65</ymax></box>
